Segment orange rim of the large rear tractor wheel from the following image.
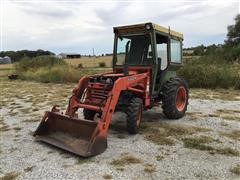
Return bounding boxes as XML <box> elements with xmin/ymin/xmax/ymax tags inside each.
<box><xmin>176</xmin><ymin>86</ymin><xmax>187</xmax><ymax>111</ymax></box>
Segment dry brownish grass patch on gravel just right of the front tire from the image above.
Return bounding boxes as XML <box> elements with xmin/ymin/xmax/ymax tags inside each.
<box><xmin>142</xmin><ymin>122</ymin><xmax>210</xmax><ymax>146</ymax></box>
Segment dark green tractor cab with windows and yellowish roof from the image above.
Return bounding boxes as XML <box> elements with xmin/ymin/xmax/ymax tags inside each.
<box><xmin>113</xmin><ymin>23</ymin><xmax>183</xmax><ymax>96</ymax></box>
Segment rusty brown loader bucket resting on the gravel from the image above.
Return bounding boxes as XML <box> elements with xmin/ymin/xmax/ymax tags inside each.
<box><xmin>34</xmin><ymin>111</ymin><xmax>107</xmax><ymax>157</ymax></box>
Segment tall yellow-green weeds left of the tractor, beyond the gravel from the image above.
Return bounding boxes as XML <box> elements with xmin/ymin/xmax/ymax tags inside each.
<box><xmin>15</xmin><ymin>56</ymin><xmax>110</xmax><ymax>83</ymax></box>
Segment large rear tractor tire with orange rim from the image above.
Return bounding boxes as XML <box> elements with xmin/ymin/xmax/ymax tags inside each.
<box><xmin>162</xmin><ymin>77</ymin><xmax>188</xmax><ymax>119</ymax></box>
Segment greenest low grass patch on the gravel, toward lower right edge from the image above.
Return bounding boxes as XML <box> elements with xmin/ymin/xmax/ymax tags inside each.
<box><xmin>182</xmin><ymin>136</ymin><xmax>239</xmax><ymax>156</ymax></box>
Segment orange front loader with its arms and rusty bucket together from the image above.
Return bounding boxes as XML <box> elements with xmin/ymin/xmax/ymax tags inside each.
<box><xmin>34</xmin><ymin>72</ymin><xmax>149</xmax><ymax>157</ymax></box>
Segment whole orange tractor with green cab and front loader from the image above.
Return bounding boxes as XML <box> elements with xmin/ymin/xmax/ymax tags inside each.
<box><xmin>34</xmin><ymin>23</ymin><xmax>188</xmax><ymax>157</ymax></box>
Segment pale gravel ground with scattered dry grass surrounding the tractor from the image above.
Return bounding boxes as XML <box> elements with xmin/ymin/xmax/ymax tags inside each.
<box><xmin>0</xmin><ymin>80</ymin><xmax>240</xmax><ymax>179</ymax></box>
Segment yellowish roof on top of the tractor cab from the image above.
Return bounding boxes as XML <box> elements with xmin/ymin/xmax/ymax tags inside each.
<box><xmin>113</xmin><ymin>22</ymin><xmax>183</xmax><ymax>40</ymax></box>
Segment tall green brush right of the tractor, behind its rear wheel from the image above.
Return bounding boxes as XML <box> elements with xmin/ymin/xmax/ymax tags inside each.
<box><xmin>178</xmin><ymin>55</ymin><xmax>240</xmax><ymax>89</ymax></box>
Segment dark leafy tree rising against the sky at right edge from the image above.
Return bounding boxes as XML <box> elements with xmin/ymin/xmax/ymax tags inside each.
<box><xmin>225</xmin><ymin>14</ymin><xmax>240</xmax><ymax>47</ymax></box>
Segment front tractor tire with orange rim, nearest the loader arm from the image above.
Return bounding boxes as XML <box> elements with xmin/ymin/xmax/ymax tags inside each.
<box><xmin>126</xmin><ymin>97</ymin><xmax>143</xmax><ymax>134</ymax></box>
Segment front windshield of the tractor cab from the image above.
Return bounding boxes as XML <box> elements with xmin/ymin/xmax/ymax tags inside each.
<box><xmin>115</xmin><ymin>35</ymin><xmax>152</xmax><ymax>65</ymax></box>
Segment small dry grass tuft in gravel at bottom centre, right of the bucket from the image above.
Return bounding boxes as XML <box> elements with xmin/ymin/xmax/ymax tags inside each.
<box><xmin>110</xmin><ymin>154</ymin><xmax>142</xmax><ymax>166</ymax></box>
